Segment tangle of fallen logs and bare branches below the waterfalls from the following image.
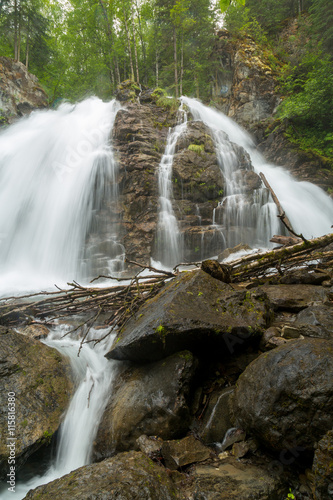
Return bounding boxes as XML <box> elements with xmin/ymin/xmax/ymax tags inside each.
<box><xmin>0</xmin><ymin>233</ymin><xmax>333</xmax><ymax>345</ymax></box>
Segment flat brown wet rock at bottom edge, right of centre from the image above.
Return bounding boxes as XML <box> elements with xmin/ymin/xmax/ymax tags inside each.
<box><xmin>187</xmin><ymin>457</ymin><xmax>286</xmax><ymax>500</ymax></box>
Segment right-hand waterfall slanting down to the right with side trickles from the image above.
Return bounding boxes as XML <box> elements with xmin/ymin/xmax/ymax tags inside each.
<box><xmin>181</xmin><ymin>97</ymin><xmax>333</xmax><ymax>247</ymax></box>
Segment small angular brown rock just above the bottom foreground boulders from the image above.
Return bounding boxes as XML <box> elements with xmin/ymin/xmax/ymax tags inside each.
<box><xmin>162</xmin><ymin>436</ymin><xmax>212</xmax><ymax>470</ymax></box>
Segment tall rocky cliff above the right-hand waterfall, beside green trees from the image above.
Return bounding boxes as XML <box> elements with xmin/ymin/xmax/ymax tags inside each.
<box><xmin>213</xmin><ymin>30</ymin><xmax>333</xmax><ymax>191</ymax></box>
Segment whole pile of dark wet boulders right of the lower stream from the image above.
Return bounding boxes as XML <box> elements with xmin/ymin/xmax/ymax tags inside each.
<box><xmin>1</xmin><ymin>248</ymin><xmax>333</xmax><ymax>500</ymax></box>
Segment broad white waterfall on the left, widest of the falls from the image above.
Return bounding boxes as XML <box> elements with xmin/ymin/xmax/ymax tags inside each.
<box><xmin>0</xmin><ymin>98</ymin><xmax>124</xmax><ymax>290</ymax></box>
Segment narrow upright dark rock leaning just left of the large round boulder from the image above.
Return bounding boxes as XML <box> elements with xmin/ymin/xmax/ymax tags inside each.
<box><xmin>199</xmin><ymin>387</ymin><xmax>234</xmax><ymax>444</ymax></box>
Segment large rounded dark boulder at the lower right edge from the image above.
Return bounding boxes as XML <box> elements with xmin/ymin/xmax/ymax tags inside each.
<box><xmin>232</xmin><ymin>339</ymin><xmax>333</xmax><ymax>452</ymax></box>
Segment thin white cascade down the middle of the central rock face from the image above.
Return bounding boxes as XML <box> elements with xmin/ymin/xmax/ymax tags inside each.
<box><xmin>155</xmin><ymin>106</ymin><xmax>187</xmax><ymax>268</ymax></box>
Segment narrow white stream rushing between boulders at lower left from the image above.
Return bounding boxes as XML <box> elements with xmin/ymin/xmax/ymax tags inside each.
<box><xmin>0</xmin><ymin>325</ymin><xmax>121</xmax><ymax>500</ymax></box>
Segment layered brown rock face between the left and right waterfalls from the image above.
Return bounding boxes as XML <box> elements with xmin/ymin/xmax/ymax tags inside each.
<box><xmin>109</xmin><ymin>85</ymin><xmax>261</xmax><ymax>264</ymax></box>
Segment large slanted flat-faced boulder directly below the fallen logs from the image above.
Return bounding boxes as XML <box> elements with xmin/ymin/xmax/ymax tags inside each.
<box><xmin>106</xmin><ymin>270</ymin><xmax>270</xmax><ymax>362</ymax></box>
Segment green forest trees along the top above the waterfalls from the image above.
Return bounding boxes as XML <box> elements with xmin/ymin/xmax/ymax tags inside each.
<box><xmin>0</xmin><ymin>0</ymin><xmax>333</xmax><ymax>157</ymax></box>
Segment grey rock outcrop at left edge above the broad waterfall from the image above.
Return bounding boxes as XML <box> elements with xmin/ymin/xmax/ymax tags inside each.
<box><xmin>0</xmin><ymin>57</ymin><xmax>47</xmax><ymax>125</ymax></box>
